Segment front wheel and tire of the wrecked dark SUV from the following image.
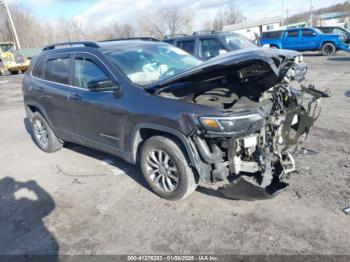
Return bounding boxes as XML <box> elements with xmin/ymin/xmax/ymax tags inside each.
<box><xmin>140</xmin><ymin>136</ymin><xmax>197</xmax><ymax>200</ymax></box>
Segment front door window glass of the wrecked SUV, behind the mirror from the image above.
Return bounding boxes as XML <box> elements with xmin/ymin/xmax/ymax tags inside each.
<box><xmin>73</xmin><ymin>58</ymin><xmax>110</xmax><ymax>89</ymax></box>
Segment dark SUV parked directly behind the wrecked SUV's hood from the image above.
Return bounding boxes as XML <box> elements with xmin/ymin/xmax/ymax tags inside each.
<box><xmin>164</xmin><ymin>33</ymin><xmax>257</xmax><ymax>61</ymax></box>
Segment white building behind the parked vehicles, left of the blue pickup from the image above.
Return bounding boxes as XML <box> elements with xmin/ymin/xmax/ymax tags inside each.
<box><xmin>222</xmin><ymin>16</ymin><xmax>282</xmax><ymax>41</ymax></box>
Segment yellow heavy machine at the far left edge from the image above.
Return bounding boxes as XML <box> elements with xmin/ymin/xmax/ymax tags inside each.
<box><xmin>0</xmin><ymin>42</ymin><xmax>30</xmax><ymax>75</ymax></box>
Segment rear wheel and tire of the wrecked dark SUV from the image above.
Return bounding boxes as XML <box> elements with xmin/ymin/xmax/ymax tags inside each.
<box><xmin>30</xmin><ymin>112</ymin><xmax>63</xmax><ymax>153</ymax></box>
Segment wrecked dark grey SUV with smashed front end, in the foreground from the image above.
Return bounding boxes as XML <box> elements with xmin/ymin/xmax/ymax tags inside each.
<box><xmin>23</xmin><ymin>40</ymin><xmax>319</xmax><ymax>200</ymax></box>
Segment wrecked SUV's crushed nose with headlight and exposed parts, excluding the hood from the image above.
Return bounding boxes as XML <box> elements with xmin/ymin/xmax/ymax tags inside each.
<box><xmin>193</xmin><ymin>73</ymin><xmax>320</xmax><ymax>200</ymax></box>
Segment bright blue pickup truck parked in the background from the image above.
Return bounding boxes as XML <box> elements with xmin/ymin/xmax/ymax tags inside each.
<box><xmin>259</xmin><ymin>28</ymin><xmax>350</xmax><ymax>56</ymax></box>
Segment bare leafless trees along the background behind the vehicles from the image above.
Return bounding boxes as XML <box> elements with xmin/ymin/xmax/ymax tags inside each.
<box><xmin>0</xmin><ymin>0</ymin><xmax>243</xmax><ymax>48</ymax></box>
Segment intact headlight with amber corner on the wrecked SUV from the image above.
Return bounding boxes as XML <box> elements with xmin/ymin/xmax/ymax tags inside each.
<box><xmin>199</xmin><ymin>112</ymin><xmax>263</xmax><ymax>133</ymax></box>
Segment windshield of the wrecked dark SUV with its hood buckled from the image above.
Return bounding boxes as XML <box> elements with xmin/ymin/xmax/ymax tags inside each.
<box><xmin>107</xmin><ymin>44</ymin><xmax>202</xmax><ymax>86</ymax></box>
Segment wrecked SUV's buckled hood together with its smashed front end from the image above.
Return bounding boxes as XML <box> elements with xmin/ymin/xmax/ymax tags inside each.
<box><xmin>154</xmin><ymin>50</ymin><xmax>321</xmax><ymax>200</ymax></box>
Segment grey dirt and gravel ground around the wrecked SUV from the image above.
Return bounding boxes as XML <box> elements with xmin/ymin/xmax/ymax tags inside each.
<box><xmin>0</xmin><ymin>51</ymin><xmax>350</xmax><ymax>255</ymax></box>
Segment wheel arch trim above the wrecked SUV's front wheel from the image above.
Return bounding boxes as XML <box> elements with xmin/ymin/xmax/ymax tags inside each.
<box><xmin>130</xmin><ymin>123</ymin><xmax>201</xmax><ymax>171</ymax></box>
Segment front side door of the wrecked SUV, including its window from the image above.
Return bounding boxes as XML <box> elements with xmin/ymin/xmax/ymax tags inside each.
<box><xmin>69</xmin><ymin>53</ymin><xmax>125</xmax><ymax>153</ymax></box>
